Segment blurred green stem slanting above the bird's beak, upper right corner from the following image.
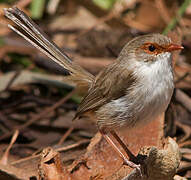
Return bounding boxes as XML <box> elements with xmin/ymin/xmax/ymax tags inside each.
<box><xmin>163</xmin><ymin>0</ymin><xmax>191</xmax><ymax>34</ymax></box>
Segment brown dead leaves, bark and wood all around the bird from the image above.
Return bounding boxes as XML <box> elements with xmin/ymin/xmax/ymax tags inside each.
<box><xmin>0</xmin><ymin>0</ymin><xmax>191</xmax><ymax>180</ymax></box>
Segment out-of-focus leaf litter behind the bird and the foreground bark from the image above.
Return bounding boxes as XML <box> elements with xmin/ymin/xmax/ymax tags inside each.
<box><xmin>0</xmin><ymin>0</ymin><xmax>191</xmax><ymax>179</ymax></box>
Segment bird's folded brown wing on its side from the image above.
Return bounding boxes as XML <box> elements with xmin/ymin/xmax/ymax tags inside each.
<box><xmin>76</xmin><ymin>63</ymin><xmax>134</xmax><ymax>117</ymax></box>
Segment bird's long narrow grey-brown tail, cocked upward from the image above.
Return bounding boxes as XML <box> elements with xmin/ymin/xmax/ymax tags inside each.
<box><xmin>4</xmin><ymin>7</ymin><xmax>94</xmax><ymax>87</ymax></box>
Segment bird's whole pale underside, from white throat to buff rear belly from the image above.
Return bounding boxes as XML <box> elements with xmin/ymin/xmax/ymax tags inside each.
<box><xmin>97</xmin><ymin>53</ymin><xmax>174</xmax><ymax>129</ymax></box>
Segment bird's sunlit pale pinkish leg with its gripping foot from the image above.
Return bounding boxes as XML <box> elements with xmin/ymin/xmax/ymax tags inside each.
<box><xmin>100</xmin><ymin>131</ymin><xmax>141</xmax><ymax>172</ymax></box>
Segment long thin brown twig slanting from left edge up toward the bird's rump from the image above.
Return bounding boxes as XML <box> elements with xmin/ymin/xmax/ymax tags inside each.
<box><xmin>0</xmin><ymin>90</ymin><xmax>75</xmax><ymax>140</ymax></box>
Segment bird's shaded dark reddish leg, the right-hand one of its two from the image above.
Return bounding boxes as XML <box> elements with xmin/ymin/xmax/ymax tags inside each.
<box><xmin>110</xmin><ymin>130</ymin><xmax>138</xmax><ymax>164</ymax></box>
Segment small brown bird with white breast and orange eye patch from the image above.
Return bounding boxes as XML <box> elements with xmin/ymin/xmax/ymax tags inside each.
<box><xmin>5</xmin><ymin>7</ymin><xmax>183</xmax><ymax>172</ymax></box>
